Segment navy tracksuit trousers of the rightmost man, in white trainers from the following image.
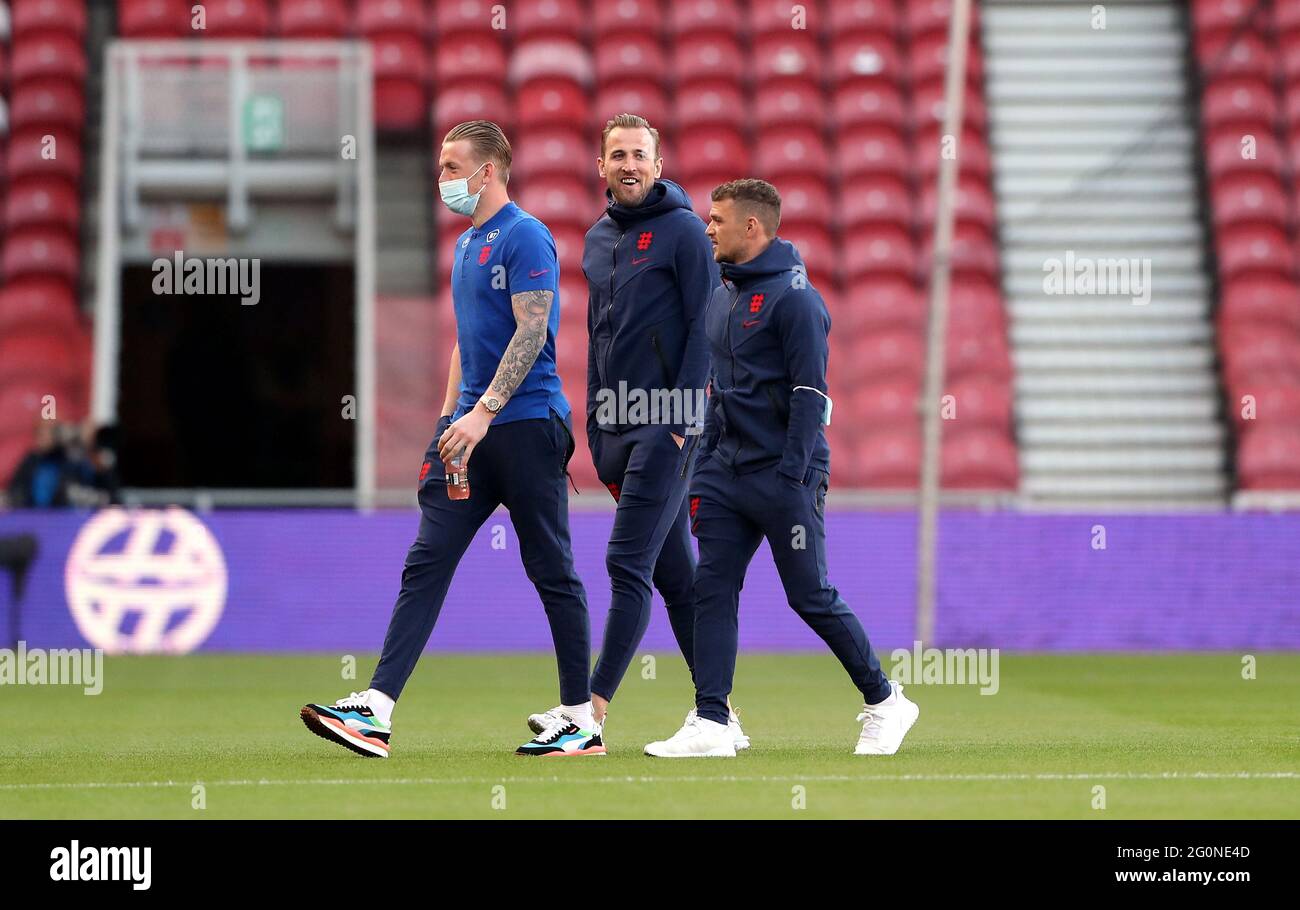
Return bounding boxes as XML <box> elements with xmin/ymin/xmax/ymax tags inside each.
<box><xmin>690</xmin><ymin>456</ymin><xmax>891</xmax><ymax>724</ymax></box>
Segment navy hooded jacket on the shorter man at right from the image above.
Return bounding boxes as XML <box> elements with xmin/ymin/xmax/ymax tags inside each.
<box><xmin>701</xmin><ymin>238</ymin><xmax>831</xmax><ymax>484</ymax></box>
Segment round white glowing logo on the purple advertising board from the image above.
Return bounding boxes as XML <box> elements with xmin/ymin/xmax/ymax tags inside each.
<box><xmin>64</xmin><ymin>508</ymin><xmax>226</xmax><ymax>654</ymax></box>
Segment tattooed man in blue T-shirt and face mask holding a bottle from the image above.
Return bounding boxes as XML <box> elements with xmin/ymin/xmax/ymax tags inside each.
<box><xmin>302</xmin><ymin>120</ymin><xmax>605</xmax><ymax>758</ymax></box>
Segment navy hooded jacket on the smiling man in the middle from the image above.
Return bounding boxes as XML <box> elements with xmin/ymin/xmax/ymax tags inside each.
<box><xmin>582</xmin><ymin>179</ymin><xmax>719</xmax><ymax>436</ymax></box>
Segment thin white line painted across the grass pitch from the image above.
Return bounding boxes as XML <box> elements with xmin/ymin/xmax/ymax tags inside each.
<box><xmin>0</xmin><ymin>771</ymin><xmax>1300</xmax><ymax>790</ymax></box>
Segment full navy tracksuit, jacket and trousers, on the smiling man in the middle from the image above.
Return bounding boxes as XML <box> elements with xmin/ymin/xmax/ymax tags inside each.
<box><xmin>582</xmin><ymin>179</ymin><xmax>719</xmax><ymax>699</ymax></box>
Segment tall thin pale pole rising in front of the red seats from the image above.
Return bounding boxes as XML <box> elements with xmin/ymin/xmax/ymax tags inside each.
<box><xmin>917</xmin><ymin>0</ymin><xmax>971</xmax><ymax>644</ymax></box>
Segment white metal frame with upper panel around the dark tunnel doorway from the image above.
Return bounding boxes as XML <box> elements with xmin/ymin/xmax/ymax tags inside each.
<box><xmin>92</xmin><ymin>40</ymin><xmax>376</xmax><ymax>508</ymax></box>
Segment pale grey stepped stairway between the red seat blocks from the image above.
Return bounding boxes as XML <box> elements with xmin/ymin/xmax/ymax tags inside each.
<box><xmin>982</xmin><ymin>0</ymin><xmax>1227</xmax><ymax>508</ymax></box>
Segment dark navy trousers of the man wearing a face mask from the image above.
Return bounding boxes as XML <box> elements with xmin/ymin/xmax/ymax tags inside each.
<box><xmin>371</xmin><ymin>411</ymin><xmax>592</xmax><ymax>705</ymax></box>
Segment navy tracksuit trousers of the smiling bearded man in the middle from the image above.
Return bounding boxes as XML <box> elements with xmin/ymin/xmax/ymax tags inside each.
<box><xmin>590</xmin><ymin>424</ymin><xmax>699</xmax><ymax>701</ymax></box>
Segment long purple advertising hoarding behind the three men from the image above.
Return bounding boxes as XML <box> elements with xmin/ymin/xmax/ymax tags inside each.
<box><xmin>0</xmin><ymin>510</ymin><xmax>1300</xmax><ymax>653</ymax></box>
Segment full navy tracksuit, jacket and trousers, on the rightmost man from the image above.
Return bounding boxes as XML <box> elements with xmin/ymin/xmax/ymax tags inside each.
<box><xmin>689</xmin><ymin>238</ymin><xmax>891</xmax><ymax>724</ymax></box>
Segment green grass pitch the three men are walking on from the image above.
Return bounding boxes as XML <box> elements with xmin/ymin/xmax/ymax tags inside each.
<box><xmin>0</xmin><ymin>654</ymin><xmax>1300</xmax><ymax>819</ymax></box>
